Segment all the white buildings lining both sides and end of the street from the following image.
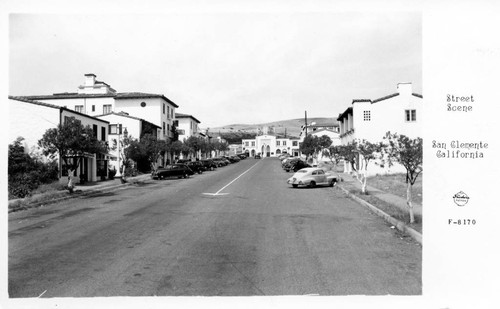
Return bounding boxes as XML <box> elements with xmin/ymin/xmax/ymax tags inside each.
<box><xmin>9</xmin><ymin>73</ymin><xmax>422</xmax><ymax>181</ymax></box>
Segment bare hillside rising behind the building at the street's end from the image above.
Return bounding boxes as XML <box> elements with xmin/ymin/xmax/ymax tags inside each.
<box><xmin>210</xmin><ymin>117</ymin><xmax>337</xmax><ymax>137</ymax></box>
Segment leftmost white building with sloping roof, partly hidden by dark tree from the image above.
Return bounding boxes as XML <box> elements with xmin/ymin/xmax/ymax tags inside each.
<box><xmin>8</xmin><ymin>96</ymin><xmax>109</xmax><ymax>181</ymax></box>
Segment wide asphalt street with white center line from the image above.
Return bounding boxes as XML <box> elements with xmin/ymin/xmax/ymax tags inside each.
<box><xmin>8</xmin><ymin>158</ymin><xmax>422</xmax><ymax>298</ymax></box>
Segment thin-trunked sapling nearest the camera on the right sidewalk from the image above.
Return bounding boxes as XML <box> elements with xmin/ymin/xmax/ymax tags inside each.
<box><xmin>384</xmin><ymin>132</ymin><xmax>423</xmax><ymax>223</ymax></box>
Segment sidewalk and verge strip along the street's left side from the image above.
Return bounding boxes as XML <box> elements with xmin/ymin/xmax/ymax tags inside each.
<box><xmin>9</xmin><ymin>174</ymin><xmax>151</xmax><ymax>213</ymax></box>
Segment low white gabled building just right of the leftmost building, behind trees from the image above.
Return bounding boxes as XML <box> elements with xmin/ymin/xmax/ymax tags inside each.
<box><xmin>96</xmin><ymin>112</ymin><xmax>161</xmax><ymax>173</ymax></box>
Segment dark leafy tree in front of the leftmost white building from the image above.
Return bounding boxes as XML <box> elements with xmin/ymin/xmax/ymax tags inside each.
<box><xmin>38</xmin><ymin>117</ymin><xmax>108</xmax><ymax>192</ymax></box>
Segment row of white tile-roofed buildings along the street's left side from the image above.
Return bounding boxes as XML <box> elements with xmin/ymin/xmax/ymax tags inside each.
<box><xmin>9</xmin><ymin>73</ymin><xmax>210</xmax><ymax>181</ymax></box>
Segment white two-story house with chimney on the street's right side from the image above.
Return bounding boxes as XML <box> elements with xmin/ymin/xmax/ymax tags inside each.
<box><xmin>337</xmin><ymin>83</ymin><xmax>423</xmax><ymax>175</ymax></box>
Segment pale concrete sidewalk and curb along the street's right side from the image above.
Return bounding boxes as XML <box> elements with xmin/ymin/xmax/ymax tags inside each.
<box><xmin>338</xmin><ymin>174</ymin><xmax>422</xmax><ymax>244</ymax></box>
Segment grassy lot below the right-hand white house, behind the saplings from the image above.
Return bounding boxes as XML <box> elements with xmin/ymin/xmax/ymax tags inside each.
<box><xmin>366</xmin><ymin>174</ymin><xmax>423</xmax><ymax>205</ymax></box>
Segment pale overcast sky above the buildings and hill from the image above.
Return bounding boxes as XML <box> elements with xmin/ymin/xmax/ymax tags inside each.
<box><xmin>9</xmin><ymin>12</ymin><xmax>422</xmax><ymax>128</ymax></box>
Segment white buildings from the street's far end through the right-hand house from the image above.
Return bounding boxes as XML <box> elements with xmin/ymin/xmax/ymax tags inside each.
<box><xmin>240</xmin><ymin>83</ymin><xmax>423</xmax><ymax>173</ymax></box>
